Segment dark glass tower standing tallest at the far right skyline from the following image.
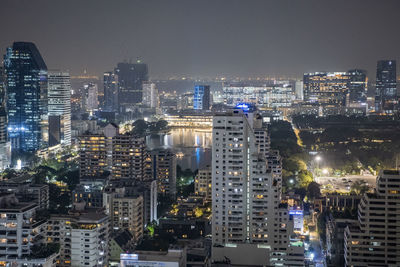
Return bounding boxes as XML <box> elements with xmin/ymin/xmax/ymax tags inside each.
<box><xmin>375</xmin><ymin>60</ymin><xmax>399</xmax><ymax>113</ymax></box>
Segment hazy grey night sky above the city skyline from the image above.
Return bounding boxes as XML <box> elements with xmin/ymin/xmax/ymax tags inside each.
<box><xmin>0</xmin><ymin>0</ymin><xmax>400</xmax><ymax>79</ymax></box>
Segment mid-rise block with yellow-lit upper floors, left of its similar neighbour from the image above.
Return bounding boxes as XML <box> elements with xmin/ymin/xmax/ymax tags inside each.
<box><xmin>79</xmin><ymin>134</ymin><xmax>107</xmax><ymax>177</ymax></box>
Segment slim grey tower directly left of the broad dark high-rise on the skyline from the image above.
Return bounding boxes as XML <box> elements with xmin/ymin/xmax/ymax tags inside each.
<box><xmin>103</xmin><ymin>71</ymin><xmax>119</xmax><ymax>112</ymax></box>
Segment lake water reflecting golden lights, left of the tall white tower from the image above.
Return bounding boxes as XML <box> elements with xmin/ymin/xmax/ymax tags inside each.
<box><xmin>146</xmin><ymin>129</ymin><xmax>212</xmax><ymax>170</ymax></box>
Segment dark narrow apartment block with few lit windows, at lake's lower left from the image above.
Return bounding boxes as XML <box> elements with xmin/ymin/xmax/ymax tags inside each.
<box><xmin>151</xmin><ymin>149</ymin><xmax>176</xmax><ymax>199</ymax></box>
